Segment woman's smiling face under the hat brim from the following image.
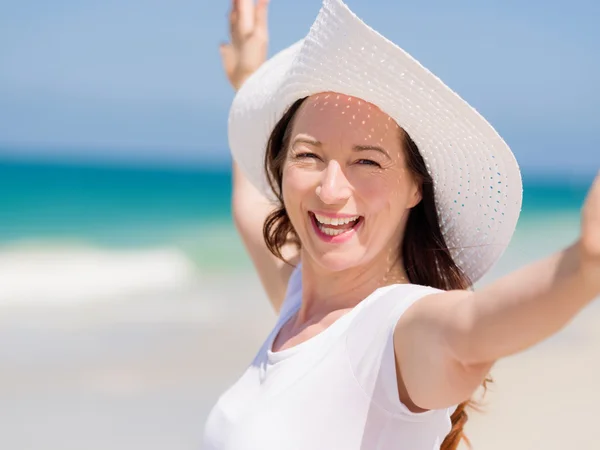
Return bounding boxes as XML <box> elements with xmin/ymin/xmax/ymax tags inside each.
<box><xmin>282</xmin><ymin>93</ymin><xmax>420</xmax><ymax>271</ymax></box>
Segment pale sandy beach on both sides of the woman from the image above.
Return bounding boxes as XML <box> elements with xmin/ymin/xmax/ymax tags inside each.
<box><xmin>0</xmin><ymin>268</ymin><xmax>600</xmax><ymax>450</ymax></box>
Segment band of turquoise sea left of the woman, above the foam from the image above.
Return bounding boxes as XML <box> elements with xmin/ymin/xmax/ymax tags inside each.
<box><xmin>0</xmin><ymin>162</ymin><xmax>231</xmax><ymax>244</ymax></box>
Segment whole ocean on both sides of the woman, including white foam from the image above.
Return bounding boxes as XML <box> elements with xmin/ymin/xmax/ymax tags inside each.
<box><xmin>0</xmin><ymin>160</ymin><xmax>592</xmax><ymax>301</ymax></box>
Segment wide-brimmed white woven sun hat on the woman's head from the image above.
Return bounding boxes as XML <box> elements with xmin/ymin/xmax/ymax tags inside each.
<box><xmin>228</xmin><ymin>0</ymin><xmax>522</xmax><ymax>282</ymax></box>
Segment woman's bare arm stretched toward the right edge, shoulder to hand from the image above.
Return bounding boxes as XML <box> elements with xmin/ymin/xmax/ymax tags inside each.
<box><xmin>394</xmin><ymin>174</ymin><xmax>600</xmax><ymax>409</ymax></box>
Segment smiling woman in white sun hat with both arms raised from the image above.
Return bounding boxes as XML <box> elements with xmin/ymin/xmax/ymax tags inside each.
<box><xmin>204</xmin><ymin>0</ymin><xmax>600</xmax><ymax>450</ymax></box>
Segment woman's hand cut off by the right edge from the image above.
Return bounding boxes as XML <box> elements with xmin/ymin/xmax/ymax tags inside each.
<box><xmin>580</xmin><ymin>172</ymin><xmax>600</xmax><ymax>285</ymax></box>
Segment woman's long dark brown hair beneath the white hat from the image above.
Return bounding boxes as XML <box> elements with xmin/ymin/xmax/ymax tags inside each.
<box><xmin>263</xmin><ymin>97</ymin><xmax>491</xmax><ymax>450</ymax></box>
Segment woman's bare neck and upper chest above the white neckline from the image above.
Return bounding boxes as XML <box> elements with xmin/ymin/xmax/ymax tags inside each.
<box><xmin>297</xmin><ymin>252</ymin><xmax>409</xmax><ymax>323</ymax></box>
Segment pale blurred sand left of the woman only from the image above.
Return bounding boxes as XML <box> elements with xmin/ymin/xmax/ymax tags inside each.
<box><xmin>0</xmin><ymin>268</ymin><xmax>274</xmax><ymax>450</ymax></box>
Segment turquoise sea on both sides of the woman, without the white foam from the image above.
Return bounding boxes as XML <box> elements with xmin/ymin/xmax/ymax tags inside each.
<box><xmin>0</xmin><ymin>161</ymin><xmax>591</xmax><ymax>265</ymax></box>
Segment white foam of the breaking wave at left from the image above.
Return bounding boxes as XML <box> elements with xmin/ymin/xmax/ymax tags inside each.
<box><xmin>0</xmin><ymin>246</ymin><xmax>202</xmax><ymax>305</ymax></box>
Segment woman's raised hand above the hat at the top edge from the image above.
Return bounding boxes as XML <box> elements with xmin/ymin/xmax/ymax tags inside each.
<box><xmin>219</xmin><ymin>0</ymin><xmax>269</xmax><ymax>90</ymax></box>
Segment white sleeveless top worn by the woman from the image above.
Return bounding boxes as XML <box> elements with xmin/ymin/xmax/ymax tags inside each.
<box><xmin>202</xmin><ymin>268</ymin><xmax>456</xmax><ymax>450</ymax></box>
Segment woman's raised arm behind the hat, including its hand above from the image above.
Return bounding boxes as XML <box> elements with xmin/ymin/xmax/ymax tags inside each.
<box><xmin>220</xmin><ymin>0</ymin><xmax>298</xmax><ymax>311</ymax></box>
